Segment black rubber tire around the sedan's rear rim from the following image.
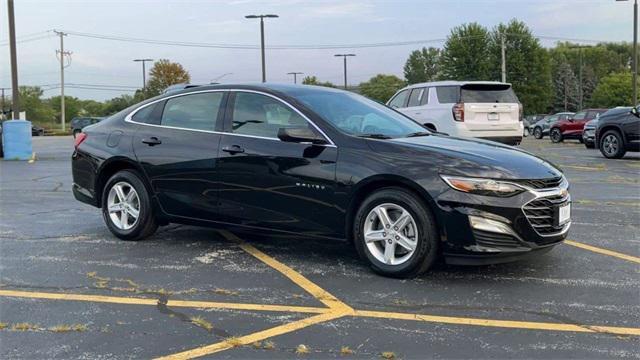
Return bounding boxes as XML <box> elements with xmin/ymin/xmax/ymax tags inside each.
<box><xmin>102</xmin><ymin>170</ymin><xmax>158</xmax><ymax>241</ymax></box>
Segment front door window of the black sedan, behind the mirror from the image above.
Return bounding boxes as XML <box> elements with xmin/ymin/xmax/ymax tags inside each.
<box><xmin>231</xmin><ymin>92</ymin><xmax>315</xmax><ymax>138</ymax></box>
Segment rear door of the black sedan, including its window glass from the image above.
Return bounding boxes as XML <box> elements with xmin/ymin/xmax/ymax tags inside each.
<box><xmin>130</xmin><ymin>90</ymin><xmax>227</xmax><ymax>220</ymax></box>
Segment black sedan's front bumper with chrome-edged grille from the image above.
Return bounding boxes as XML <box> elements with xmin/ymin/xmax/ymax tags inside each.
<box><xmin>436</xmin><ymin>179</ymin><xmax>571</xmax><ymax>264</ymax></box>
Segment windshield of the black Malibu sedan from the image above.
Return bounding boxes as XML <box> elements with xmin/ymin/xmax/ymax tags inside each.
<box><xmin>296</xmin><ymin>91</ymin><xmax>428</xmax><ymax>138</ymax></box>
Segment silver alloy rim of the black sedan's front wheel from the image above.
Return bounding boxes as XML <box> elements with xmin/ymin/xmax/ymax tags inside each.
<box><xmin>363</xmin><ymin>203</ymin><xmax>418</xmax><ymax>265</ymax></box>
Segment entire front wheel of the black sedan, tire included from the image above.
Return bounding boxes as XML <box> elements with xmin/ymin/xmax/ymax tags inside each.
<box><xmin>353</xmin><ymin>188</ymin><xmax>438</xmax><ymax>278</ymax></box>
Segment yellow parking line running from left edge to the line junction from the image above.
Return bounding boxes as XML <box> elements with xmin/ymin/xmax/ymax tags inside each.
<box><xmin>0</xmin><ymin>290</ymin><xmax>328</xmax><ymax>314</ymax></box>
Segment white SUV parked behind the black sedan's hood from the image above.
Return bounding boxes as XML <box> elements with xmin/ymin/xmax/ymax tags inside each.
<box><xmin>387</xmin><ymin>81</ymin><xmax>524</xmax><ymax>145</ymax></box>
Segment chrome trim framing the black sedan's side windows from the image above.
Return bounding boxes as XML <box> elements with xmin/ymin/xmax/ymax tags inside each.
<box><xmin>124</xmin><ymin>89</ymin><xmax>337</xmax><ymax>148</ymax></box>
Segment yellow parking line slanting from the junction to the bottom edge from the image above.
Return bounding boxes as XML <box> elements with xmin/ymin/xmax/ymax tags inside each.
<box><xmin>157</xmin><ymin>310</ymin><xmax>344</xmax><ymax>360</ymax></box>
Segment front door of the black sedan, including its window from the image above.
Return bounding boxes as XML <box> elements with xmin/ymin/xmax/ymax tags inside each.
<box><xmin>217</xmin><ymin>91</ymin><xmax>343</xmax><ymax>236</ymax></box>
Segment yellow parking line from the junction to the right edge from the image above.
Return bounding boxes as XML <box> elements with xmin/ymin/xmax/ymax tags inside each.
<box><xmin>354</xmin><ymin>310</ymin><xmax>640</xmax><ymax>336</ymax></box>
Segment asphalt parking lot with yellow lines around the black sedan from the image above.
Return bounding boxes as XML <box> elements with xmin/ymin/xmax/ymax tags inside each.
<box><xmin>0</xmin><ymin>137</ymin><xmax>640</xmax><ymax>359</ymax></box>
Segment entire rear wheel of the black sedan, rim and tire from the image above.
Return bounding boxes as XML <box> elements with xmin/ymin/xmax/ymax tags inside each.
<box><xmin>102</xmin><ymin>170</ymin><xmax>158</xmax><ymax>240</ymax></box>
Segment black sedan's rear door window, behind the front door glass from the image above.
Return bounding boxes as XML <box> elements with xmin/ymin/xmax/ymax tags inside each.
<box><xmin>160</xmin><ymin>91</ymin><xmax>224</xmax><ymax>131</ymax></box>
